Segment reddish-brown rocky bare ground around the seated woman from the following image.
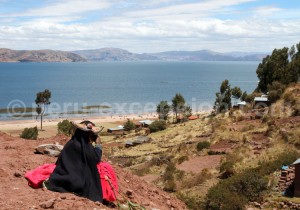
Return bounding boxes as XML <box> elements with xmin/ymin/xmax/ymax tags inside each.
<box><xmin>0</xmin><ymin>132</ymin><xmax>187</xmax><ymax>210</ymax></box>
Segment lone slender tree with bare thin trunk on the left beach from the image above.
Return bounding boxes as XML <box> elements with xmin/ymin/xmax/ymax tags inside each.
<box><xmin>35</xmin><ymin>89</ymin><xmax>51</xmax><ymax>130</ymax></box>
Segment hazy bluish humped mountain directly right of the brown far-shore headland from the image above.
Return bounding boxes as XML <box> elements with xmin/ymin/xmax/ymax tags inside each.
<box><xmin>73</xmin><ymin>48</ymin><xmax>158</xmax><ymax>61</ymax></box>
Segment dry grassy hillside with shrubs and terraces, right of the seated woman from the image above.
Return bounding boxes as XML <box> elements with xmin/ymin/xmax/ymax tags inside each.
<box><xmin>106</xmin><ymin>84</ymin><xmax>300</xmax><ymax>210</ymax></box>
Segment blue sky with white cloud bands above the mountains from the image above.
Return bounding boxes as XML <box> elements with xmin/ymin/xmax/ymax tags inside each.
<box><xmin>0</xmin><ymin>0</ymin><xmax>300</xmax><ymax>53</ymax></box>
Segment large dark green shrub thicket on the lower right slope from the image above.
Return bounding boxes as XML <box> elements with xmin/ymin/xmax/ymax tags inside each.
<box><xmin>205</xmin><ymin>150</ymin><xmax>299</xmax><ymax>210</ymax></box>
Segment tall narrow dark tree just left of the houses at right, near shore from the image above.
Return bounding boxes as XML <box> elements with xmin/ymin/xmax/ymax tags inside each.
<box><xmin>214</xmin><ymin>79</ymin><xmax>231</xmax><ymax>113</ymax></box>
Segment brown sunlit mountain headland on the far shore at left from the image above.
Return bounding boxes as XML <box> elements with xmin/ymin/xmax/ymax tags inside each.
<box><xmin>0</xmin><ymin>48</ymin><xmax>86</xmax><ymax>62</ymax></box>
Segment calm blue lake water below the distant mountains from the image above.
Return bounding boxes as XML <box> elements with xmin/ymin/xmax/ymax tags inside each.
<box><xmin>0</xmin><ymin>62</ymin><xmax>258</xmax><ymax>119</ymax></box>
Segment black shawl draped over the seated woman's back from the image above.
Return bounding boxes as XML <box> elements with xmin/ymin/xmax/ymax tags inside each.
<box><xmin>47</xmin><ymin>129</ymin><xmax>103</xmax><ymax>202</ymax></box>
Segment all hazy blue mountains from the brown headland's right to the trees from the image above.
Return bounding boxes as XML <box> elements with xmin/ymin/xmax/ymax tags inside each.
<box><xmin>73</xmin><ymin>48</ymin><xmax>266</xmax><ymax>61</ymax></box>
